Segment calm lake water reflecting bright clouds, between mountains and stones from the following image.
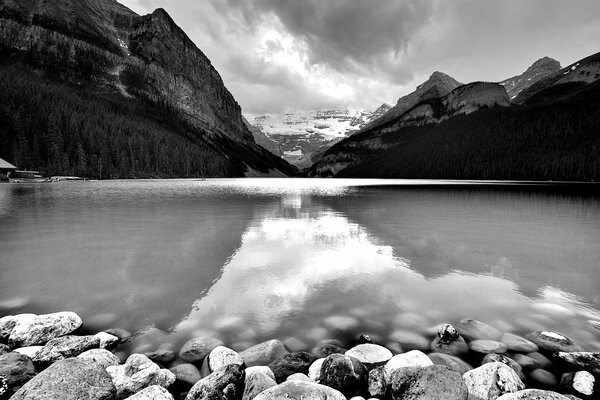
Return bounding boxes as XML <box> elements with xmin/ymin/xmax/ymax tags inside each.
<box><xmin>0</xmin><ymin>179</ymin><xmax>600</xmax><ymax>351</ymax></box>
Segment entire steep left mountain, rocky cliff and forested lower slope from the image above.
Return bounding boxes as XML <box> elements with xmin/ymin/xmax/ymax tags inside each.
<box><xmin>0</xmin><ymin>0</ymin><xmax>295</xmax><ymax>178</ymax></box>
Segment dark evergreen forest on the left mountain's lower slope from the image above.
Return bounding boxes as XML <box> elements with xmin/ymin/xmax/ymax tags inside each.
<box><xmin>0</xmin><ymin>64</ymin><xmax>245</xmax><ymax>179</ymax></box>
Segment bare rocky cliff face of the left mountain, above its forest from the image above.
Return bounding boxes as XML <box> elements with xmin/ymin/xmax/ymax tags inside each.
<box><xmin>0</xmin><ymin>0</ymin><xmax>294</xmax><ymax>175</ymax></box>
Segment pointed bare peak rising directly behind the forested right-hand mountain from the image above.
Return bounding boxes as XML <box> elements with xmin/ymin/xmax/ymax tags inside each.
<box><xmin>361</xmin><ymin>71</ymin><xmax>461</xmax><ymax>130</ymax></box>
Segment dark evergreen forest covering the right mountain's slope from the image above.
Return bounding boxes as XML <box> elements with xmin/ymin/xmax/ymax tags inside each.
<box><xmin>311</xmin><ymin>81</ymin><xmax>600</xmax><ymax>181</ymax></box>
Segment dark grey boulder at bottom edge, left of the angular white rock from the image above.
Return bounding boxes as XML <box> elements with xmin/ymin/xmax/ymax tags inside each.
<box><xmin>388</xmin><ymin>365</ymin><xmax>468</xmax><ymax>400</ymax></box>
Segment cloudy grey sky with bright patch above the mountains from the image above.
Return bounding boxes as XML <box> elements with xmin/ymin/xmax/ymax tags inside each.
<box><xmin>120</xmin><ymin>0</ymin><xmax>600</xmax><ymax>116</ymax></box>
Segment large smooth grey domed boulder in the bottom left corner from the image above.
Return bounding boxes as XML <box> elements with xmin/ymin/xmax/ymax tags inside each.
<box><xmin>11</xmin><ymin>358</ymin><xmax>116</xmax><ymax>400</ymax></box>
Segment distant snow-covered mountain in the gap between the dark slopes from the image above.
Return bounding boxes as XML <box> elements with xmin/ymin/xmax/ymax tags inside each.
<box><xmin>251</xmin><ymin>104</ymin><xmax>391</xmax><ymax>168</ymax></box>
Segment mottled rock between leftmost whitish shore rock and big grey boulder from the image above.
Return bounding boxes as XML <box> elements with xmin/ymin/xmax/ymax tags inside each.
<box><xmin>32</xmin><ymin>335</ymin><xmax>100</xmax><ymax>367</ymax></box>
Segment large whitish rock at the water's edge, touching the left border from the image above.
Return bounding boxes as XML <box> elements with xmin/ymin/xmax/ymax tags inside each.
<box><xmin>0</xmin><ymin>311</ymin><xmax>83</xmax><ymax>348</ymax></box>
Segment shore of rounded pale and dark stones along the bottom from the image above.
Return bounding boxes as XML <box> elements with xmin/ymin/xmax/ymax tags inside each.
<box><xmin>0</xmin><ymin>312</ymin><xmax>600</xmax><ymax>400</ymax></box>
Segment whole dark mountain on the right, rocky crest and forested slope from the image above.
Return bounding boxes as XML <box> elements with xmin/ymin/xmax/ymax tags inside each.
<box><xmin>309</xmin><ymin>53</ymin><xmax>600</xmax><ymax>181</ymax></box>
